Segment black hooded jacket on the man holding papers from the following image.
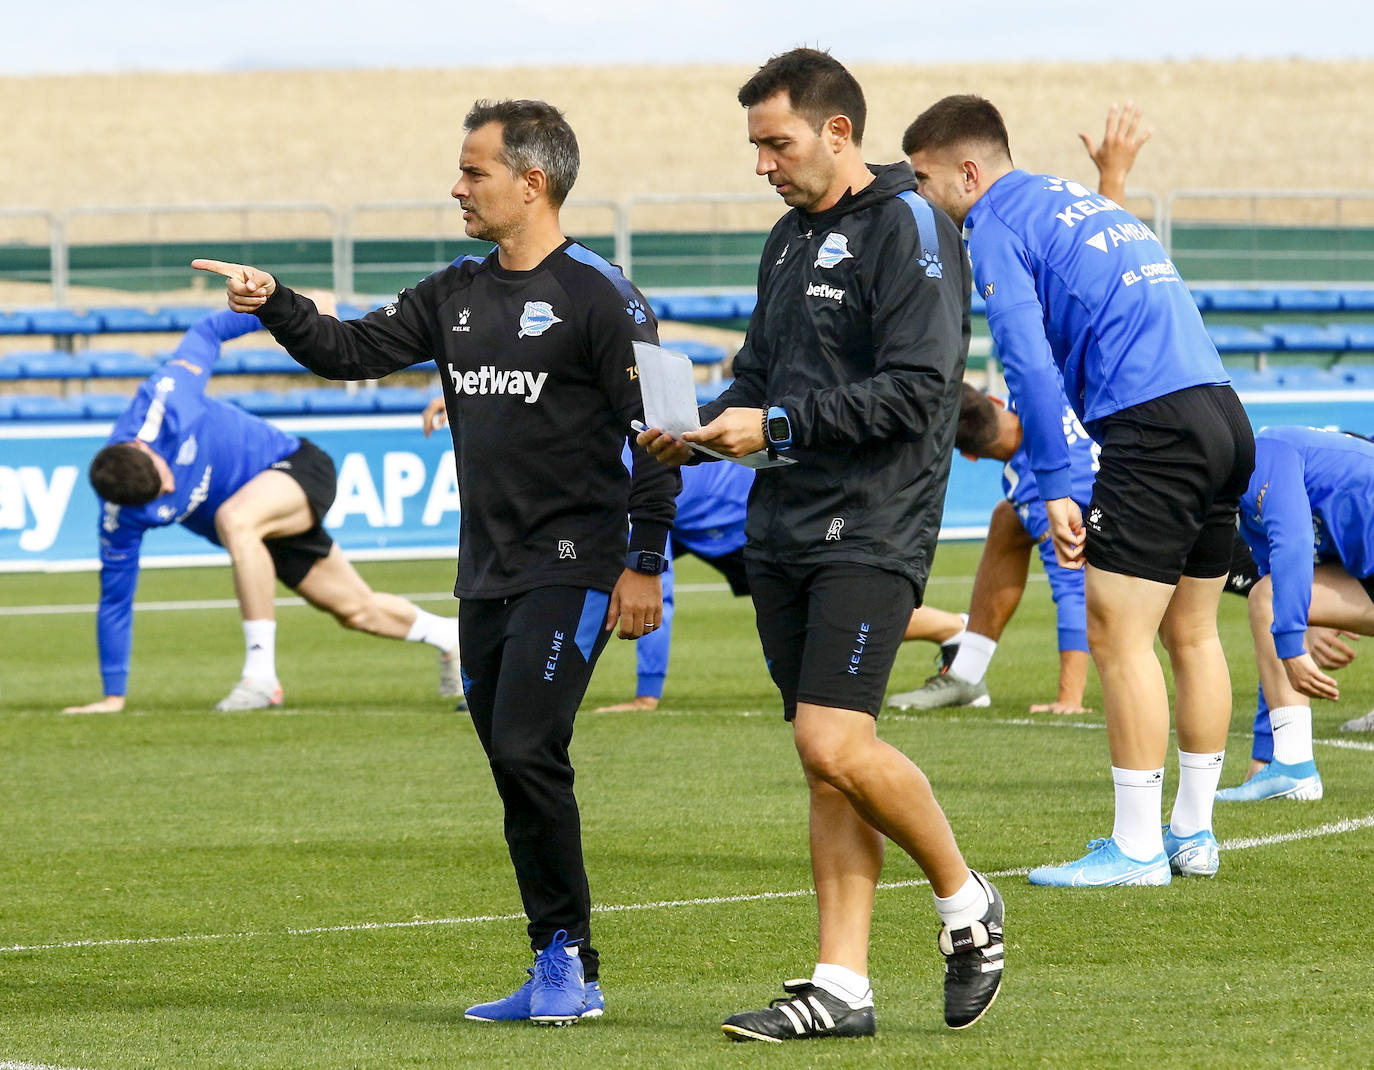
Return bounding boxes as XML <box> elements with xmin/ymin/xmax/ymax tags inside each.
<box><xmin>701</xmin><ymin>163</ymin><xmax>973</xmax><ymax>595</ymax></box>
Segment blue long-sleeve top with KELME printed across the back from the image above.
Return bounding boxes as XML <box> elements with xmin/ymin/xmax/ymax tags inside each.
<box><xmin>965</xmin><ymin>170</ymin><xmax>1230</xmax><ymax>501</ymax></box>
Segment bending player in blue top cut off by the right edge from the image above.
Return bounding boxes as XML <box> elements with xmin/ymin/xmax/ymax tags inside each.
<box><xmin>1217</xmin><ymin>427</ymin><xmax>1374</xmax><ymax>802</ymax></box>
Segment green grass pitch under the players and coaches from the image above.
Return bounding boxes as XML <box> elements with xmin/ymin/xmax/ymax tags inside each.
<box><xmin>0</xmin><ymin>544</ymin><xmax>1374</xmax><ymax>1070</ymax></box>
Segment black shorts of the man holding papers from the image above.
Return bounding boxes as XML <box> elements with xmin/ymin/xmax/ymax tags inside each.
<box><xmin>749</xmin><ymin>559</ymin><xmax>916</xmax><ymax>721</ymax></box>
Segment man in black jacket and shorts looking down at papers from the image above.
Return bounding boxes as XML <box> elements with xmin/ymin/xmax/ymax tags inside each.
<box><xmin>640</xmin><ymin>48</ymin><xmax>1002</xmax><ymax>1041</ymax></box>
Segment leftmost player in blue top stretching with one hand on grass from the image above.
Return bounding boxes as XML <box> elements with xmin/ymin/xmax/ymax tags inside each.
<box><xmin>66</xmin><ymin>298</ymin><xmax>462</xmax><ymax>713</ymax></box>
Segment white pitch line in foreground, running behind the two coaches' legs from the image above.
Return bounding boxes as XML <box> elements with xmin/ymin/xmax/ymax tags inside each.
<box><xmin>0</xmin><ymin>813</ymin><xmax>1374</xmax><ymax>955</ymax></box>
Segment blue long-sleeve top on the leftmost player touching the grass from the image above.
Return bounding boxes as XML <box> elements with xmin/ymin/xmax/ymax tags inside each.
<box><xmin>96</xmin><ymin>310</ymin><xmax>301</xmax><ymax>695</ymax></box>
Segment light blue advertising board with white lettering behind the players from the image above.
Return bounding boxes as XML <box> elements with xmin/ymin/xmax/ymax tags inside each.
<box><xmin>0</xmin><ymin>390</ymin><xmax>1374</xmax><ymax>571</ymax></box>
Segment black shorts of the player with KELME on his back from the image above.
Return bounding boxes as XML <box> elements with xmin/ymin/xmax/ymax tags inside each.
<box><xmin>1083</xmin><ymin>386</ymin><xmax>1254</xmax><ymax>584</ymax></box>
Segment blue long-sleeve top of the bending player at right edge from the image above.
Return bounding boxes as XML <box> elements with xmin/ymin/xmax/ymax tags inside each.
<box><xmin>1241</xmin><ymin>427</ymin><xmax>1374</xmax><ymax>658</ymax></box>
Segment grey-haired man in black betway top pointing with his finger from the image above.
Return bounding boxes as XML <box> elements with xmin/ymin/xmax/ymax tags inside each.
<box><xmin>195</xmin><ymin>100</ymin><xmax>679</xmax><ymax>1025</ymax></box>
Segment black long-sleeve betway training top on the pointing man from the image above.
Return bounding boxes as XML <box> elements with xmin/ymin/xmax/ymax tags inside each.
<box><xmin>257</xmin><ymin>242</ymin><xmax>682</xmax><ymax>599</ymax></box>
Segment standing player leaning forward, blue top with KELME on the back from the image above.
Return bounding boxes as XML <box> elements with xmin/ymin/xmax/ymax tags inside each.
<box><xmin>903</xmin><ymin>96</ymin><xmax>1254</xmax><ymax>886</ymax></box>
